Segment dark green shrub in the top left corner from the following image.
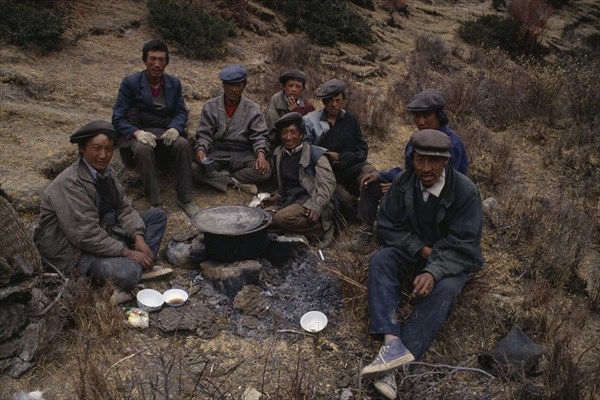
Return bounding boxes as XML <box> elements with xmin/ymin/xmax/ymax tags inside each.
<box><xmin>0</xmin><ymin>0</ymin><xmax>65</xmax><ymax>53</ymax></box>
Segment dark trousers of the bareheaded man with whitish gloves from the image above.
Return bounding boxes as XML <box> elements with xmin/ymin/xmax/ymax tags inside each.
<box><xmin>119</xmin><ymin>136</ymin><xmax>192</xmax><ymax>205</ymax></box>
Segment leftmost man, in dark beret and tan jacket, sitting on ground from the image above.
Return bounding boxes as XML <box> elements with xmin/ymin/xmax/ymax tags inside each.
<box><xmin>34</xmin><ymin>121</ymin><xmax>167</xmax><ymax>298</ymax></box>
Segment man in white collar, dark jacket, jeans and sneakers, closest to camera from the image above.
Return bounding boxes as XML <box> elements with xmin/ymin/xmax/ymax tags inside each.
<box><xmin>361</xmin><ymin>129</ymin><xmax>483</xmax><ymax>399</ymax></box>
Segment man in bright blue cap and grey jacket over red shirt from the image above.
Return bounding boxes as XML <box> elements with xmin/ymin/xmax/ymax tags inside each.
<box><xmin>192</xmin><ymin>65</ymin><xmax>271</xmax><ymax>194</ymax></box>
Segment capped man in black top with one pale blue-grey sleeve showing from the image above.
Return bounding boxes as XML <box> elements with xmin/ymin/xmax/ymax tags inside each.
<box><xmin>303</xmin><ymin>79</ymin><xmax>376</xmax><ymax>219</ymax></box>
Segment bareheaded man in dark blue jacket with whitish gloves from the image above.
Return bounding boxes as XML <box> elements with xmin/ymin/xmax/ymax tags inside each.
<box><xmin>112</xmin><ymin>40</ymin><xmax>199</xmax><ymax>215</ymax></box>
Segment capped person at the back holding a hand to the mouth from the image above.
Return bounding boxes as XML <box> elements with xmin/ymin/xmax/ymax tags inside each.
<box><xmin>266</xmin><ymin>69</ymin><xmax>315</xmax><ymax>149</ymax></box>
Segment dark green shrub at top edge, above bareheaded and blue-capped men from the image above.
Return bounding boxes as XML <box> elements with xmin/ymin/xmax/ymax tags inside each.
<box><xmin>147</xmin><ymin>0</ymin><xmax>235</xmax><ymax>59</ymax></box>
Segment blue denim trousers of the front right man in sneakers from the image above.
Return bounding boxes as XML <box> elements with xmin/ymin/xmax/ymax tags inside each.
<box><xmin>368</xmin><ymin>247</ymin><xmax>469</xmax><ymax>359</ymax></box>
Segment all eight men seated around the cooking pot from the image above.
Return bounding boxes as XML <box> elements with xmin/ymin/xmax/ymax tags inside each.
<box><xmin>35</xmin><ymin>40</ymin><xmax>483</xmax><ymax>398</ymax></box>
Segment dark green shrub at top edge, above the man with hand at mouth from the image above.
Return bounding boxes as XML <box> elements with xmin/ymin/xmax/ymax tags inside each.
<box><xmin>262</xmin><ymin>0</ymin><xmax>372</xmax><ymax>46</ymax></box>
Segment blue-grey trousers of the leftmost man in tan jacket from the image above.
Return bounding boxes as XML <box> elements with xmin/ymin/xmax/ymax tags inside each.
<box><xmin>78</xmin><ymin>208</ymin><xmax>167</xmax><ymax>289</ymax></box>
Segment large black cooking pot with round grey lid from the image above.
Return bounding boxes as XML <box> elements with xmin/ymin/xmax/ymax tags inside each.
<box><xmin>191</xmin><ymin>206</ymin><xmax>272</xmax><ymax>262</ymax></box>
